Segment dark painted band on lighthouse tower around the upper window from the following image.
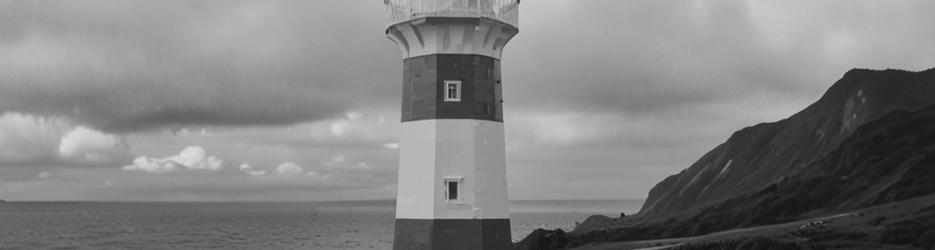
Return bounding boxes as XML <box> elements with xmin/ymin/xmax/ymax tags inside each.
<box><xmin>401</xmin><ymin>54</ymin><xmax>503</xmax><ymax>122</ymax></box>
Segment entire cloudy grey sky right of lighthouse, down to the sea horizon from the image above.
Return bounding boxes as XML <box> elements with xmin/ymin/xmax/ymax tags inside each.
<box><xmin>503</xmin><ymin>0</ymin><xmax>935</xmax><ymax>198</ymax></box>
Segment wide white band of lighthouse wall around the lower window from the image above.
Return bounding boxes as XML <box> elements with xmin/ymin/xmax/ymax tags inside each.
<box><xmin>396</xmin><ymin>119</ymin><xmax>509</xmax><ymax>219</ymax></box>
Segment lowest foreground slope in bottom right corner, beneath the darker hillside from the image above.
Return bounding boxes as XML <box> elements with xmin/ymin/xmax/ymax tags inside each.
<box><xmin>573</xmin><ymin>195</ymin><xmax>935</xmax><ymax>250</ymax></box>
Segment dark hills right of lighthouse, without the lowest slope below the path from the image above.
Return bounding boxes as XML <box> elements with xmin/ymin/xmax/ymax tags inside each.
<box><xmin>518</xmin><ymin>69</ymin><xmax>935</xmax><ymax>249</ymax></box>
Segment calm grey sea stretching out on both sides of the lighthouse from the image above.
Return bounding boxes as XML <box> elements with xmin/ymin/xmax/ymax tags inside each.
<box><xmin>0</xmin><ymin>200</ymin><xmax>642</xmax><ymax>249</ymax></box>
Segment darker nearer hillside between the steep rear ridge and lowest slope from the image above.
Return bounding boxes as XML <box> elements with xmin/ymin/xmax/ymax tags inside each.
<box><xmin>660</xmin><ymin>98</ymin><xmax>935</xmax><ymax>234</ymax></box>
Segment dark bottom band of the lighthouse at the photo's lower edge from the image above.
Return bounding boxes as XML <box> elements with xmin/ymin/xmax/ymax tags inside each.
<box><xmin>393</xmin><ymin>219</ymin><xmax>512</xmax><ymax>250</ymax></box>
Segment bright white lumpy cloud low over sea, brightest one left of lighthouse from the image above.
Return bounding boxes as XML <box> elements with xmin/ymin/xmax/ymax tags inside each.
<box><xmin>122</xmin><ymin>146</ymin><xmax>224</xmax><ymax>173</ymax></box>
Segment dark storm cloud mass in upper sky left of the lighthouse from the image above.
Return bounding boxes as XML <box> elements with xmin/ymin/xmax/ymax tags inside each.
<box><xmin>0</xmin><ymin>1</ymin><xmax>398</xmax><ymax>132</ymax></box>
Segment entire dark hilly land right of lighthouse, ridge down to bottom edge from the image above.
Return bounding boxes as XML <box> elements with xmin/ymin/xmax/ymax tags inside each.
<box><xmin>515</xmin><ymin>69</ymin><xmax>935</xmax><ymax>249</ymax></box>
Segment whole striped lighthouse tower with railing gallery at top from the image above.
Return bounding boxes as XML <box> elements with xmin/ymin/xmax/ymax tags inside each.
<box><xmin>384</xmin><ymin>0</ymin><xmax>519</xmax><ymax>250</ymax></box>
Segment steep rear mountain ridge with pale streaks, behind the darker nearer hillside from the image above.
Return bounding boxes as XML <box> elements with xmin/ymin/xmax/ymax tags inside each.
<box><xmin>641</xmin><ymin>69</ymin><xmax>935</xmax><ymax>216</ymax></box>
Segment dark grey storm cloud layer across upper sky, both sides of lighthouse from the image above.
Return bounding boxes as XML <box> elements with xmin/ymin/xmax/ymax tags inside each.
<box><xmin>0</xmin><ymin>0</ymin><xmax>935</xmax><ymax>131</ymax></box>
